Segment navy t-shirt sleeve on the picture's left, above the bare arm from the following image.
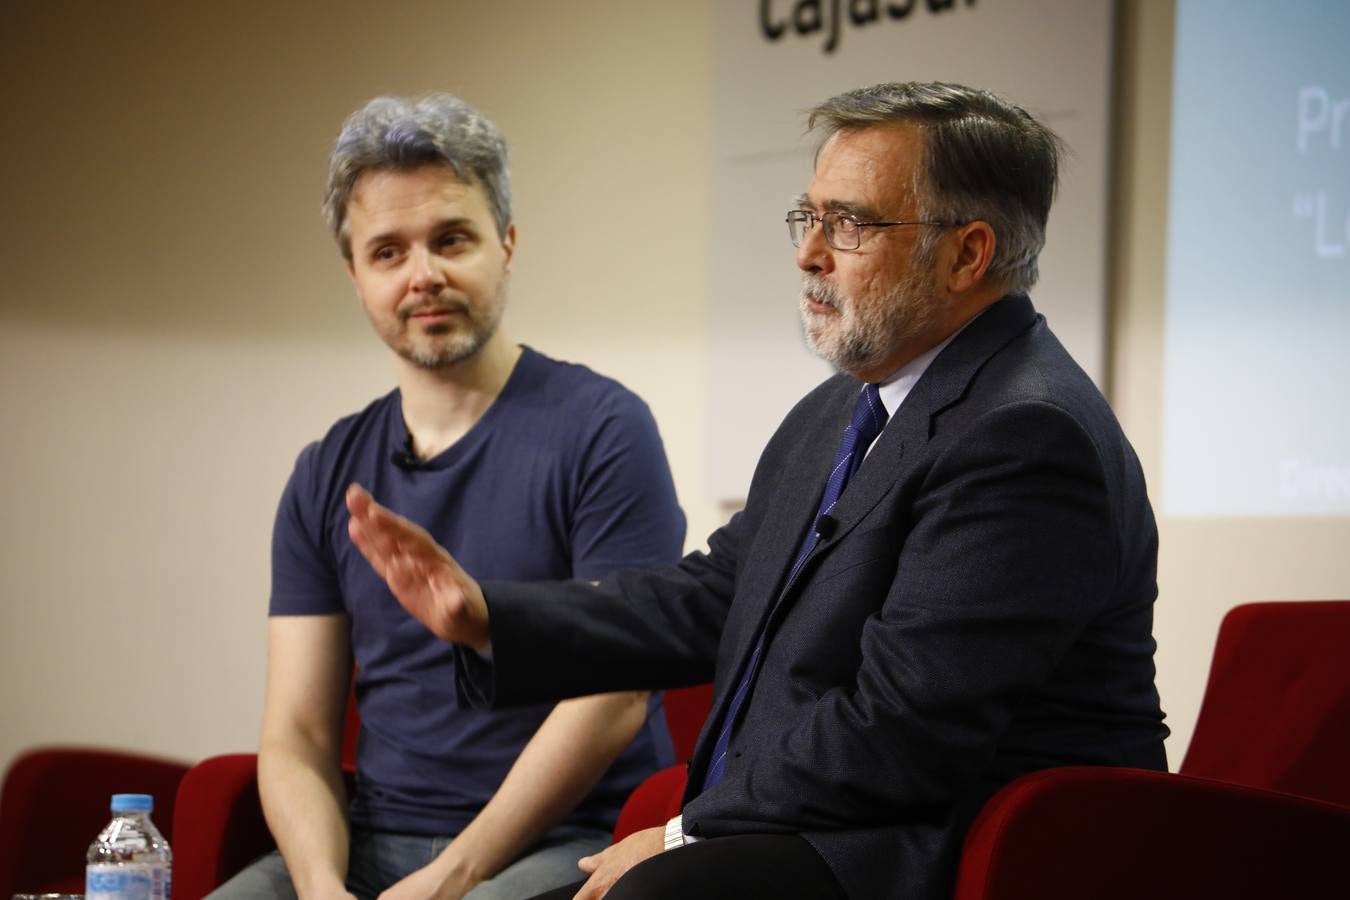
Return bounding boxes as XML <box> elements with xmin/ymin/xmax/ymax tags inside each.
<box><xmin>269</xmin><ymin>444</ymin><xmax>346</xmax><ymax>615</ymax></box>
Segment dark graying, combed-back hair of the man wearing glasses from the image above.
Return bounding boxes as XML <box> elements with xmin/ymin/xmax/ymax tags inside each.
<box><xmin>807</xmin><ymin>81</ymin><xmax>1064</xmax><ymax>291</ymax></box>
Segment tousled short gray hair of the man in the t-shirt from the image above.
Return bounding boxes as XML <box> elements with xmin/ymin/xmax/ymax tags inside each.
<box><xmin>324</xmin><ymin>93</ymin><xmax>512</xmax><ymax>259</ymax></box>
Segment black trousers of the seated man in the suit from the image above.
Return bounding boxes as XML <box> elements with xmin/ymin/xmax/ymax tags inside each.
<box><xmin>535</xmin><ymin>834</ymin><xmax>845</xmax><ymax>900</ymax></box>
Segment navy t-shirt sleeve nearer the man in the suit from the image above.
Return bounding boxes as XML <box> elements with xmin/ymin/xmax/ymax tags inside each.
<box><xmin>571</xmin><ymin>389</ymin><xmax>684</xmax><ymax>580</ymax></box>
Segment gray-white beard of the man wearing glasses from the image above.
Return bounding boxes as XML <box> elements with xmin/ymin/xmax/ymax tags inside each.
<box><xmin>801</xmin><ymin>260</ymin><xmax>940</xmax><ymax>374</ymax></box>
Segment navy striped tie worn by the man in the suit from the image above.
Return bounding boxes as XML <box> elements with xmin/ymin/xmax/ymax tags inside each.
<box><xmin>703</xmin><ymin>385</ymin><xmax>887</xmax><ymax>791</ymax></box>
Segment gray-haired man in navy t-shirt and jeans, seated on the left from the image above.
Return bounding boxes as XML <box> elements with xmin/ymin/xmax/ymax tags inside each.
<box><xmin>217</xmin><ymin>94</ymin><xmax>684</xmax><ymax>900</ymax></box>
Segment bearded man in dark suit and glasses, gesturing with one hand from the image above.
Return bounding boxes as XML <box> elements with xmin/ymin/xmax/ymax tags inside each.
<box><xmin>348</xmin><ymin>84</ymin><xmax>1166</xmax><ymax>900</ymax></box>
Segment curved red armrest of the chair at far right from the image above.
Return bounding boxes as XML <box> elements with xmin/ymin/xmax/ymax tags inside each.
<box><xmin>956</xmin><ymin>766</ymin><xmax>1350</xmax><ymax>900</ymax></box>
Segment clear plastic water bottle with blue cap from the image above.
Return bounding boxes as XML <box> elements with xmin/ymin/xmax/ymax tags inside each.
<box><xmin>85</xmin><ymin>793</ymin><xmax>173</xmax><ymax>900</ymax></box>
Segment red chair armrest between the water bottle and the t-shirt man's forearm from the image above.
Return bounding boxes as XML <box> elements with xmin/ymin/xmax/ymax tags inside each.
<box><xmin>171</xmin><ymin>753</ymin><xmax>275</xmax><ymax>900</ymax></box>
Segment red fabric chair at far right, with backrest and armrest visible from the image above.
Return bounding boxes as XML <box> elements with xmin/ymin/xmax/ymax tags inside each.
<box><xmin>956</xmin><ymin>600</ymin><xmax>1350</xmax><ymax>900</ymax></box>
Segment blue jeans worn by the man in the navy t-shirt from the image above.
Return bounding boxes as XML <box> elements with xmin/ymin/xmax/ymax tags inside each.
<box><xmin>209</xmin><ymin>826</ymin><xmax>610</xmax><ymax>900</ymax></box>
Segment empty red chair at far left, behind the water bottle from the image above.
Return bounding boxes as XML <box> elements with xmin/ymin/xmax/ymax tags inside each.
<box><xmin>0</xmin><ymin>746</ymin><xmax>188</xmax><ymax>897</ymax></box>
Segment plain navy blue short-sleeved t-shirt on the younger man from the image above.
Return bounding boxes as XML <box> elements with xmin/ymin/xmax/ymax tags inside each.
<box><xmin>270</xmin><ymin>347</ymin><xmax>684</xmax><ymax>835</ymax></box>
